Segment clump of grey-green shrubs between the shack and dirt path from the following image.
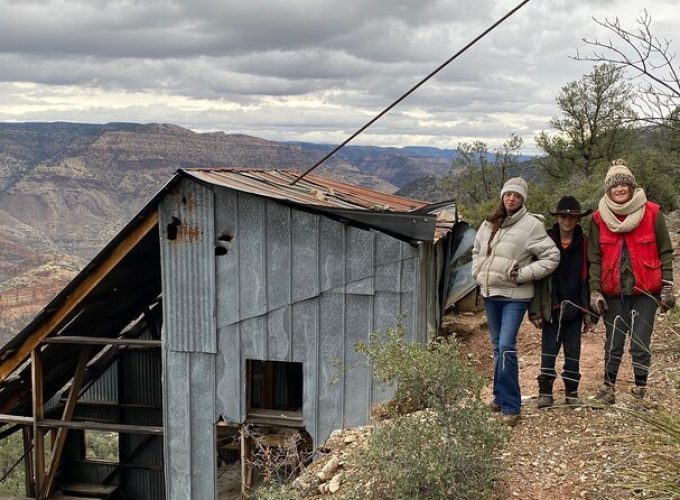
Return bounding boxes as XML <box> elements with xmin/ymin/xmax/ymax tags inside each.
<box><xmin>346</xmin><ymin>326</ymin><xmax>507</xmax><ymax>499</ymax></box>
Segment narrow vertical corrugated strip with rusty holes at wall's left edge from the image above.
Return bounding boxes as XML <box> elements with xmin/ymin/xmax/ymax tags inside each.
<box><xmin>159</xmin><ymin>180</ymin><xmax>217</xmax><ymax>499</ymax></box>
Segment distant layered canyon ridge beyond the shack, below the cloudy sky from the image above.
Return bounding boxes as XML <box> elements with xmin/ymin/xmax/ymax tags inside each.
<box><xmin>0</xmin><ymin>122</ymin><xmax>450</xmax><ymax>286</ymax></box>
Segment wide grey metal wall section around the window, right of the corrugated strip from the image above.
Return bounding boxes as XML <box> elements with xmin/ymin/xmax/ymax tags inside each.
<box><xmin>215</xmin><ymin>189</ymin><xmax>422</xmax><ymax>443</ymax></box>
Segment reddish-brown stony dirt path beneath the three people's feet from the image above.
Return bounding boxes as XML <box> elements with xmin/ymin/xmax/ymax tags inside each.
<box><xmin>463</xmin><ymin>308</ymin><xmax>680</xmax><ymax>500</ymax></box>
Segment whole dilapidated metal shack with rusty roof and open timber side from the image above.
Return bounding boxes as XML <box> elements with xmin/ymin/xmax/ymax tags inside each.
<box><xmin>0</xmin><ymin>169</ymin><xmax>476</xmax><ymax>499</ymax></box>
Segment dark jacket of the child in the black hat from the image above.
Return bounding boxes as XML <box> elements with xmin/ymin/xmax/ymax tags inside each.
<box><xmin>529</xmin><ymin>224</ymin><xmax>590</xmax><ymax>322</ymax></box>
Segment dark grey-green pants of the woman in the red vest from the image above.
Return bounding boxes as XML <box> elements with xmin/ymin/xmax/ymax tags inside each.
<box><xmin>604</xmin><ymin>295</ymin><xmax>657</xmax><ymax>385</ymax></box>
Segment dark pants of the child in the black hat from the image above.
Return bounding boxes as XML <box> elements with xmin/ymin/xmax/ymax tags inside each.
<box><xmin>538</xmin><ymin>314</ymin><xmax>583</xmax><ymax>396</ymax></box>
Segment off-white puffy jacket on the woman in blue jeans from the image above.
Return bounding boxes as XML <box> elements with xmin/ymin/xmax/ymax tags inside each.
<box><xmin>472</xmin><ymin>206</ymin><xmax>560</xmax><ymax>300</ymax></box>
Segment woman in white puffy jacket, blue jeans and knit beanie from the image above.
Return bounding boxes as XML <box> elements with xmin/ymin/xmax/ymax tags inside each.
<box><xmin>472</xmin><ymin>177</ymin><xmax>560</xmax><ymax>426</ymax></box>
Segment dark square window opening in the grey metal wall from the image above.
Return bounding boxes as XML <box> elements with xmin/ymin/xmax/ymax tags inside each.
<box><xmin>246</xmin><ymin>359</ymin><xmax>303</xmax><ymax>411</ymax></box>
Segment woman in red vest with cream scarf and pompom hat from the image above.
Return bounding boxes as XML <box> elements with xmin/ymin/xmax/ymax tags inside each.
<box><xmin>588</xmin><ymin>159</ymin><xmax>675</xmax><ymax>404</ymax></box>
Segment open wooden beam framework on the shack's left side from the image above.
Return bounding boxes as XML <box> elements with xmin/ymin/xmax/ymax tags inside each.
<box><xmin>0</xmin><ymin>211</ymin><xmax>163</xmax><ymax>498</ymax></box>
